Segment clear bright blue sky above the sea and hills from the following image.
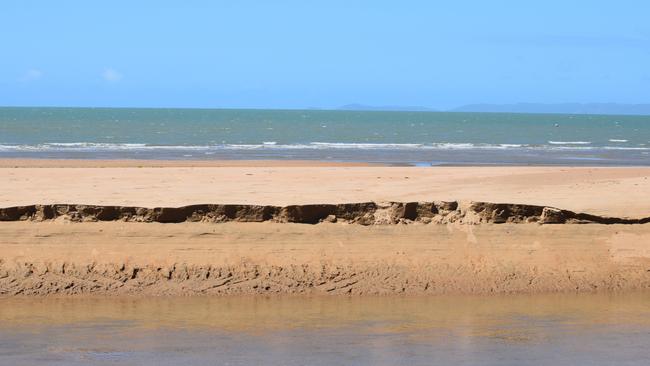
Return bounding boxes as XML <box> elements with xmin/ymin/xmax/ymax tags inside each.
<box><xmin>0</xmin><ymin>0</ymin><xmax>650</xmax><ymax>109</ymax></box>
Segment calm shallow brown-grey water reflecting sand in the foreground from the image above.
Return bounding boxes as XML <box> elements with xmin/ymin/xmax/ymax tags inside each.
<box><xmin>0</xmin><ymin>293</ymin><xmax>650</xmax><ymax>365</ymax></box>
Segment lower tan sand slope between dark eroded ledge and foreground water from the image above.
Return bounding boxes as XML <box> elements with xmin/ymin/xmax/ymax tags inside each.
<box><xmin>0</xmin><ymin>221</ymin><xmax>650</xmax><ymax>296</ymax></box>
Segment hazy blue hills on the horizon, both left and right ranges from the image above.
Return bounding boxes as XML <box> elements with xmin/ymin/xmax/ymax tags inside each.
<box><xmin>338</xmin><ymin>103</ymin><xmax>650</xmax><ymax>115</ymax></box>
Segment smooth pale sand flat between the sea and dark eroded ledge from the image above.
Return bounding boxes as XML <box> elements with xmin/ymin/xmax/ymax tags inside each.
<box><xmin>0</xmin><ymin>161</ymin><xmax>650</xmax><ymax>218</ymax></box>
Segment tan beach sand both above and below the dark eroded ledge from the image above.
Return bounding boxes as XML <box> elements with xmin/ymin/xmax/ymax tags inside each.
<box><xmin>0</xmin><ymin>160</ymin><xmax>650</xmax><ymax>296</ymax></box>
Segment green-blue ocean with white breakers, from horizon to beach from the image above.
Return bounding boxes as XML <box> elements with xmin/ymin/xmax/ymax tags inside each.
<box><xmin>0</xmin><ymin>107</ymin><xmax>650</xmax><ymax>166</ymax></box>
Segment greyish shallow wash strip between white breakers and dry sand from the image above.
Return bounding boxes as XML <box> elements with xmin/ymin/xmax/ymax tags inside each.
<box><xmin>0</xmin><ymin>148</ymin><xmax>650</xmax><ymax>166</ymax></box>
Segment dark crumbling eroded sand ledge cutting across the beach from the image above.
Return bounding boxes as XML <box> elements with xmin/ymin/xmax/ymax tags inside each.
<box><xmin>0</xmin><ymin>201</ymin><xmax>650</xmax><ymax>225</ymax></box>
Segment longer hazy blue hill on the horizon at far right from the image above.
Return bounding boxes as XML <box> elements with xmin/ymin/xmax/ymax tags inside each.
<box><xmin>451</xmin><ymin>103</ymin><xmax>650</xmax><ymax>115</ymax></box>
